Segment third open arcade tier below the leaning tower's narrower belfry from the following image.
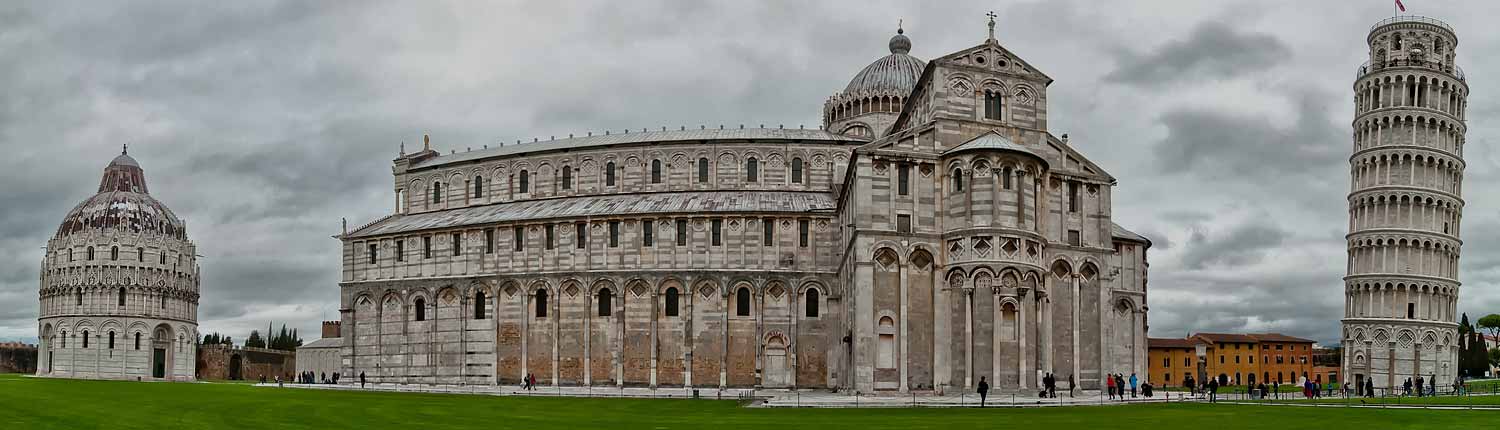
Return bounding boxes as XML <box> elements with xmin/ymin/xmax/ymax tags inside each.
<box><xmin>1352</xmin><ymin>154</ymin><xmax>1464</xmax><ymax>195</ymax></box>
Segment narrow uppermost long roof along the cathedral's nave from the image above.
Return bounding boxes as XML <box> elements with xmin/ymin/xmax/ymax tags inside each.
<box><xmin>410</xmin><ymin>129</ymin><xmax>864</xmax><ymax>169</ymax></box>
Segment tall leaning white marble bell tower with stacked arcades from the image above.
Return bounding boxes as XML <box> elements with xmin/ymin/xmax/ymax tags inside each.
<box><xmin>1343</xmin><ymin>16</ymin><xmax>1469</xmax><ymax>393</ymax></box>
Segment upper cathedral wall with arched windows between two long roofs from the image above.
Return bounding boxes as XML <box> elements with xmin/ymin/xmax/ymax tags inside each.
<box><xmin>398</xmin><ymin>150</ymin><xmax>848</xmax><ymax>213</ymax></box>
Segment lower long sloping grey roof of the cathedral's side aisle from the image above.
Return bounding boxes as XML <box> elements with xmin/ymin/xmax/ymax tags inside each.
<box><xmin>344</xmin><ymin>192</ymin><xmax>834</xmax><ymax>238</ymax></box>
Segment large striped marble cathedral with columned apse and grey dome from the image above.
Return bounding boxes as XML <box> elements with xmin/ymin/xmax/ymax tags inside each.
<box><xmin>338</xmin><ymin>18</ymin><xmax>1151</xmax><ymax>394</ymax></box>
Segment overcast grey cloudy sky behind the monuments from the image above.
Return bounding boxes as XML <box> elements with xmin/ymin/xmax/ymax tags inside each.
<box><xmin>0</xmin><ymin>0</ymin><xmax>1500</xmax><ymax>342</ymax></box>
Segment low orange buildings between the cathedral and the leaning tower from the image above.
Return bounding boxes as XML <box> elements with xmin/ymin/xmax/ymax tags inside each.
<box><xmin>1148</xmin><ymin>333</ymin><xmax>1328</xmax><ymax>387</ymax></box>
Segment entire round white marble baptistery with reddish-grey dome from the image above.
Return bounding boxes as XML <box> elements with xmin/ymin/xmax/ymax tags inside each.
<box><xmin>36</xmin><ymin>148</ymin><xmax>200</xmax><ymax>381</ymax></box>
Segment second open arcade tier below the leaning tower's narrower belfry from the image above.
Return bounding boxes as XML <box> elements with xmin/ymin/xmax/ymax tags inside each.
<box><xmin>1355</xmin><ymin>114</ymin><xmax>1467</xmax><ymax>156</ymax></box>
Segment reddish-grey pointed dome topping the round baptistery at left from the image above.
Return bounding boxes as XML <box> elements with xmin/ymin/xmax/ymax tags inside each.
<box><xmin>57</xmin><ymin>153</ymin><xmax>186</xmax><ymax>240</ymax></box>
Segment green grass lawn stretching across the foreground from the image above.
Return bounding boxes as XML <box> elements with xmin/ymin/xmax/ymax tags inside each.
<box><xmin>0</xmin><ymin>375</ymin><xmax>1500</xmax><ymax>430</ymax></box>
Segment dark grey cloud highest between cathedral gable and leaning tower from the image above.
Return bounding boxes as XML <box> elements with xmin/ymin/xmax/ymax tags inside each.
<box><xmin>1104</xmin><ymin>21</ymin><xmax>1292</xmax><ymax>88</ymax></box>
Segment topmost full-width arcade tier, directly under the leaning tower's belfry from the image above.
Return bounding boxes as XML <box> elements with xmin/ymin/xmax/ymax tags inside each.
<box><xmin>1355</xmin><ymin>75</ymin><xmax>1469</xmax><ymax>118</ymax></box>
